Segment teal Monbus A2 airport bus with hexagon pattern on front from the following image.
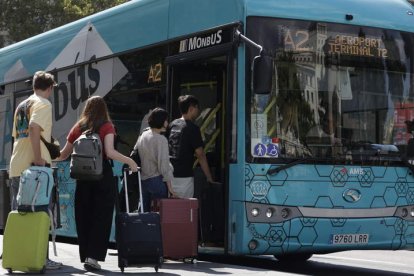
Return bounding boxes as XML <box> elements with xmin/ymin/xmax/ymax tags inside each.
<box><xmin>0</xmin><ymin>0</ymin><xmax>414</xmax><ymax>260</ymax></box>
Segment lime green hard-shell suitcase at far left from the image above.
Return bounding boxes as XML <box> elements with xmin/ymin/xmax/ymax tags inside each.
<box><xmin>3</xmin><ymin>211</ymin><xmax>50</xmax><ymax>273</ymax></box>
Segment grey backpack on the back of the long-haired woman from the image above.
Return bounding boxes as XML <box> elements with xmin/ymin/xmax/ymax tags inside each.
<box><xmin>70</xmin><ymin>132</ymin><xmax>103</xmax><ymax>181</ymax></box>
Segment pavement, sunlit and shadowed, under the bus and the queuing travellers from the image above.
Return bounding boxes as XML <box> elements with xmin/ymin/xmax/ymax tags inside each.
<box><xmin>0</xmin><ymin>236</ymin><xmax>414</xmax><ymax>276</ymax></box>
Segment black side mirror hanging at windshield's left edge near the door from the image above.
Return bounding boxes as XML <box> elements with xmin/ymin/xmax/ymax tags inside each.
<box><xmin>252</xmin><ymin>55</ymin><xmax>273</xmax><ymax>94</ymax></box>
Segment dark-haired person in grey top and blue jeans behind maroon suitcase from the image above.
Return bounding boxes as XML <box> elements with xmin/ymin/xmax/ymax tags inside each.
<box><xmin>137</xmin><ymin>108</ymin><xmax>176</xmax><ymax>212</ymax></box>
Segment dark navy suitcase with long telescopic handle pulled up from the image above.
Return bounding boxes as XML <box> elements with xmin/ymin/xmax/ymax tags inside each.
<box><xmin>115</xmin><ymin>170</ymin><xmax>163</xmax><ymax>272</ymax></box>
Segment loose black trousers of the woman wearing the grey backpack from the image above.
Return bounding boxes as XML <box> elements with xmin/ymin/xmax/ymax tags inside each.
<box><xmin>75</xmin><ymin>160</ymin><xmax>117</xmax><ymax>262</ymax></box>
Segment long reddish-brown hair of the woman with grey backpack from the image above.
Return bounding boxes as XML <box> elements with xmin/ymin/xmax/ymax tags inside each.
<box><xmin>78</xmin><ymin>96</ymin><xmax>111</xmax><ymax>132</ymax></box>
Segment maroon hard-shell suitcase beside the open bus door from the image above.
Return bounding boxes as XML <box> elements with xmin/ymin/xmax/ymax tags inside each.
<box><xmin>159</xmin><ymin>198</ymin><xmax>198</xmax><ymax>263</ymax></box>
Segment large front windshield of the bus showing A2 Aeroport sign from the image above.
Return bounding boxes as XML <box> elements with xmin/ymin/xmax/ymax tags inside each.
<box><xmin>246</xmin><ymin>17</ymin><xmax>414</xmax><ymax>164</ymax></box>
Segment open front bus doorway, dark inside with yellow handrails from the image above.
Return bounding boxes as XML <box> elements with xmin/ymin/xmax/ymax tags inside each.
<box><xmin>168</xmin><ymin>55</ymin><xmax>229</xmax><ymax>247</ymax></box>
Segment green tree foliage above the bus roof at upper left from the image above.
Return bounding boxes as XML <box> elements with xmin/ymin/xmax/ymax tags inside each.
<box><xmin>0</xmin><ymin>0</ymin><xmax>128</xmax><ymax>47</ymax></box>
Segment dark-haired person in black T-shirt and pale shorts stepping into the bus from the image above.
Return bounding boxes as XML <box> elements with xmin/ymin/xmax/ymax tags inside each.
<box><xmin>167</xmin><ymin>95</ymin><xmax>214</xmax><ymax>198</ymax></box>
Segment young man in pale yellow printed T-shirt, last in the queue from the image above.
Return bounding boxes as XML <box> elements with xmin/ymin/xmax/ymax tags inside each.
<box><xmin>9</xmin><ymin>71</ymin><xmax>62</xmax><ymax>269</ymax></box>
